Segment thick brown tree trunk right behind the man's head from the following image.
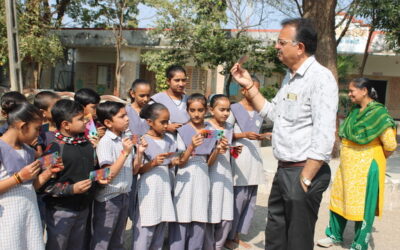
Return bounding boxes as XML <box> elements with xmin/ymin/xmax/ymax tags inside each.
<box><xmin>303</xmin><ymin>0</ymin><xmax>338</xmax><ymax>80</ymax></box>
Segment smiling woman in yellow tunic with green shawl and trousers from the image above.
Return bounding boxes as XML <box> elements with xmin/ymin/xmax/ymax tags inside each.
<box><xmin>317</xmin><ymin>78</ymin><xmax>397</xmax><ymax>250</ymax></box>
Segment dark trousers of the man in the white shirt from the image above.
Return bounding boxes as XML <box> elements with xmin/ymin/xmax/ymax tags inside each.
<box><xmin>265</xmin><ymin>162</ymin><xmax>331</xmax><ymax>250</ymax></box>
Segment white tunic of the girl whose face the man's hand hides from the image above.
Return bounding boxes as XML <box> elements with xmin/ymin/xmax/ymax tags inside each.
<box><xmin>227</xmin><ymin>111</ymin><xmax>265</xmax><ymax>186</ymax></box>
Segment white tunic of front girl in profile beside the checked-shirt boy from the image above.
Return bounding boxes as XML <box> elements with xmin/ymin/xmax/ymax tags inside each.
<box><xmin>137</xmin><ymin>135</ymin><xmax>176</xmax><ymax>227</ymax></box>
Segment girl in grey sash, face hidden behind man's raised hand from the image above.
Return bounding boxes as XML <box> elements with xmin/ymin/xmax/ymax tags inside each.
<box><xmin>225</xmin><ymin>77</ymin><xmax>265</xmax><ymax>249</ymax></box>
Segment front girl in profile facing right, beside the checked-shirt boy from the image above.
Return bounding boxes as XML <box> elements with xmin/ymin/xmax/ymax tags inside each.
<box><xmin>133</xmin><ymin>103</ymin><xmax>198</xmax><ymax>249</ymax></box>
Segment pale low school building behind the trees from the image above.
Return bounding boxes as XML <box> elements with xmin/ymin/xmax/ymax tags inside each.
<box><xmin>32</xmin><ymin>16</ymin><xmax>400</xmax><ymax>119</ymax></box>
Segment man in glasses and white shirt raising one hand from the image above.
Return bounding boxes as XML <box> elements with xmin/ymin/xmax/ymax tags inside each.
<box><xmin>231</xmin><ymin>18</ymin><xmax>338</xmax><ymax>250</ymax></box>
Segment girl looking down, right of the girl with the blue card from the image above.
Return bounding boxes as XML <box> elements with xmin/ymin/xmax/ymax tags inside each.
<box><xmin>204</xmin><ymin>94</ymin><xmax>233</xmax><ymax>249</ymax></box>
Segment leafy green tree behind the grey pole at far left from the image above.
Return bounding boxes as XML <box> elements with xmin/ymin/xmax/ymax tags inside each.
<box><xmin>0</xmin><ymin>0</ymin><xmax>69</xmax><ymax>88</ymax></box>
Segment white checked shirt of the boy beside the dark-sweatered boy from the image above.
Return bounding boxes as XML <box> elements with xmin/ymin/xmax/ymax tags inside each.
<box><xmin>95</xmin><ymin>129</ymin><xmax>134</xmax><ymax>202</ymax></box>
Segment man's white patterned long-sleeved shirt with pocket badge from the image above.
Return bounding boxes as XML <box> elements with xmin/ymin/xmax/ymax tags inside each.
<box><xmin>260</xmin><ymin>56</ymin><xmax>339</xmax><ymax>162</ymax></box>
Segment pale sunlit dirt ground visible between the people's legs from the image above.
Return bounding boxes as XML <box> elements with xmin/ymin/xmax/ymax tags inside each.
<box><xmin>125</xmin><ymin>157</ymin><xmax>400</xmax><ymax>250</ymax></box>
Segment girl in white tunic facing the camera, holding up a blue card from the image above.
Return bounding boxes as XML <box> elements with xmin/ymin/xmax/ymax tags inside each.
<box><xmin>169</xmin><ymin>94</ymin><xmax>221</xmax><ymax>250</ymax></box>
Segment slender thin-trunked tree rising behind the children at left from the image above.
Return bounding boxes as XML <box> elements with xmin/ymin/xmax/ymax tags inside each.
<box><xmin>68</xmin><ymin>0</ymin><xmax>140</xmax><ymax>96</ymax></box>
